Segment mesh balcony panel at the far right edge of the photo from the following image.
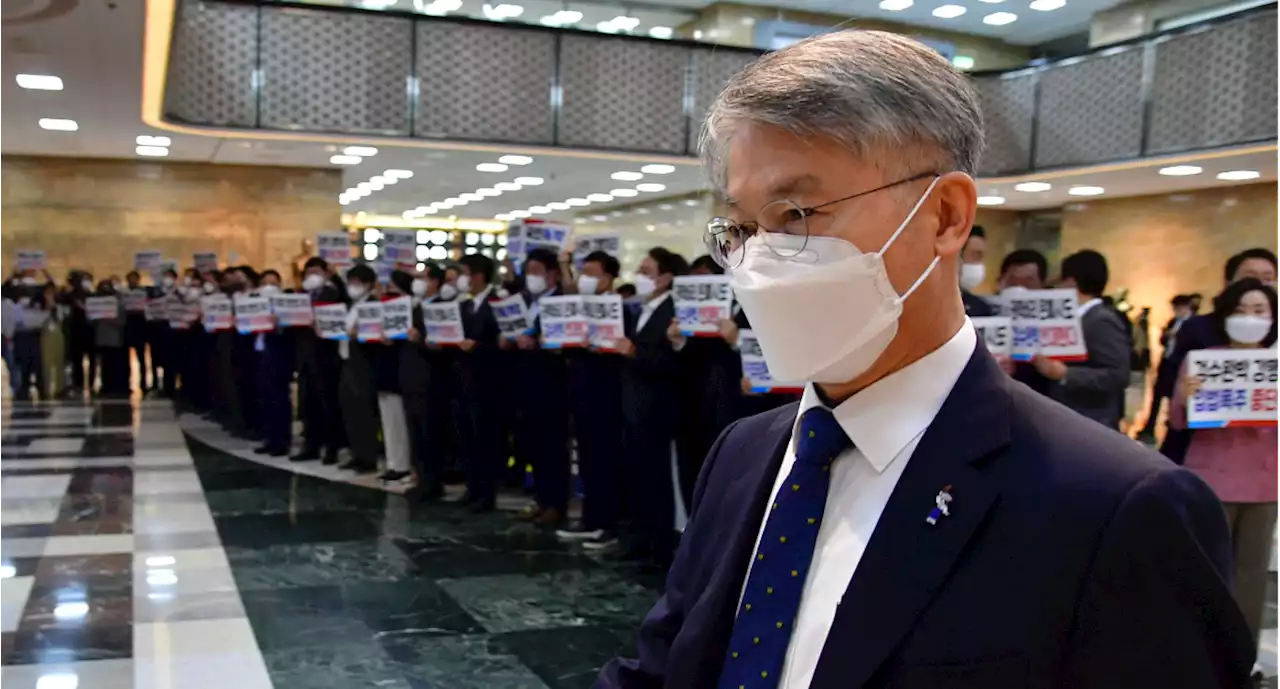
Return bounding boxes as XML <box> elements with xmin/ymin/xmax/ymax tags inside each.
<box><xmin>1147</xmin><ymin>12</ymin><xmax>1280</xmax><ymax>154</ymax></box>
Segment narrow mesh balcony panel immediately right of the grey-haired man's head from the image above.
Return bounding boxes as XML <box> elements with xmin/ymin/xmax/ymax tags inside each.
<box><xmin>973</xmin><ymin>72</ymin><xmax>1037</xmax><ymax>174</ymax></box>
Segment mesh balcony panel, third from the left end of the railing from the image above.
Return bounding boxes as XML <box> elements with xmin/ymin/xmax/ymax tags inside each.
<box><xmin>413</xmin><ymin>20</ymin><xmax>556</xmax><ymax>143</ymax></box>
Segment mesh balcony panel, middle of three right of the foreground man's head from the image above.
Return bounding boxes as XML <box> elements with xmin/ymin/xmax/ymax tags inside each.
<box><xmin>1036</xmin><ymin>46</ymin><xmax>1143</xmax><ymax>168</ymax></box>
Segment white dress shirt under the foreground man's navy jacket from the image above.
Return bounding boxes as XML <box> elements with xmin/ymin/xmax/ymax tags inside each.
<box><xmin>739</xmin><ymin>319</ymin><xmax>978</xmax><ymax>689</ymax></box>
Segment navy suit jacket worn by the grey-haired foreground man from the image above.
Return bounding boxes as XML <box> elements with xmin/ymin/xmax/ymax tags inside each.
<box><xmin>595</xmin><ymin>347</ymin><xmax>1256</xmax><ymax>689</ymax></box>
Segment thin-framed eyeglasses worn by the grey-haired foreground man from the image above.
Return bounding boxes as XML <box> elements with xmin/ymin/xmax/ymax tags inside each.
<box><xmin>704</xmin><ymin>172</ymin><xmax>942</xmax><ymax>269</ymax></box>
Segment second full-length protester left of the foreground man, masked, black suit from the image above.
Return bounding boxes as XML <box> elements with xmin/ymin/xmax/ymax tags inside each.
<box><xmin>617</xmin><ymin>247</ymin><xmax>689</xmax><ymax>567</ymax></box>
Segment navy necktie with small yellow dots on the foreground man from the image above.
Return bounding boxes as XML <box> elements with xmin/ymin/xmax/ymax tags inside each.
<box><xmin>718</xmin><ymin>407</ymin><xmax>850</xmax><ymax>689</ymax></box>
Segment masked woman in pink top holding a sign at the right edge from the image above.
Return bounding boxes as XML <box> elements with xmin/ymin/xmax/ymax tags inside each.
<box><xmin>1169</xmin><ymin>278</ymin><xmax>1280</xmax><ymax>677</ymax></box>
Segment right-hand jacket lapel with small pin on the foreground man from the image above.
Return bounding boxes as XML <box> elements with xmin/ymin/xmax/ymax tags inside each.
<box><xmin>812</xmin><ymin>347</ymin><xmax>1010</xmax><ymax>688</ymax></box>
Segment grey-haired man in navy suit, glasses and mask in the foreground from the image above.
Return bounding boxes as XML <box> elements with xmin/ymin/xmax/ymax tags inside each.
<box><xmin>595</xmin><ymin>31</ymin><xmax>1256</xmax><ymax>689</ymax></box>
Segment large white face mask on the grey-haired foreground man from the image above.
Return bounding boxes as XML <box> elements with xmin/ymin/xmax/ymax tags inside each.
<box><xmin>731</xmin><ymin>178</ymin><xmax>940</xmax><ymax>383</ymax></box>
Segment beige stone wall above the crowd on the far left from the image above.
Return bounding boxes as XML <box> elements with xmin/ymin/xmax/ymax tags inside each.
<box><xmin>0</xmin><ymin>156</ymin><xmax>342</xmax><ymax>279</ymax></box>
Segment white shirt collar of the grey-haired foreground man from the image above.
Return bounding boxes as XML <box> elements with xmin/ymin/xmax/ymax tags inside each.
<box><xmin>796</xmin><ymin>318</ymin><xmax>978</xmax><ymax>471</ymax></box>
